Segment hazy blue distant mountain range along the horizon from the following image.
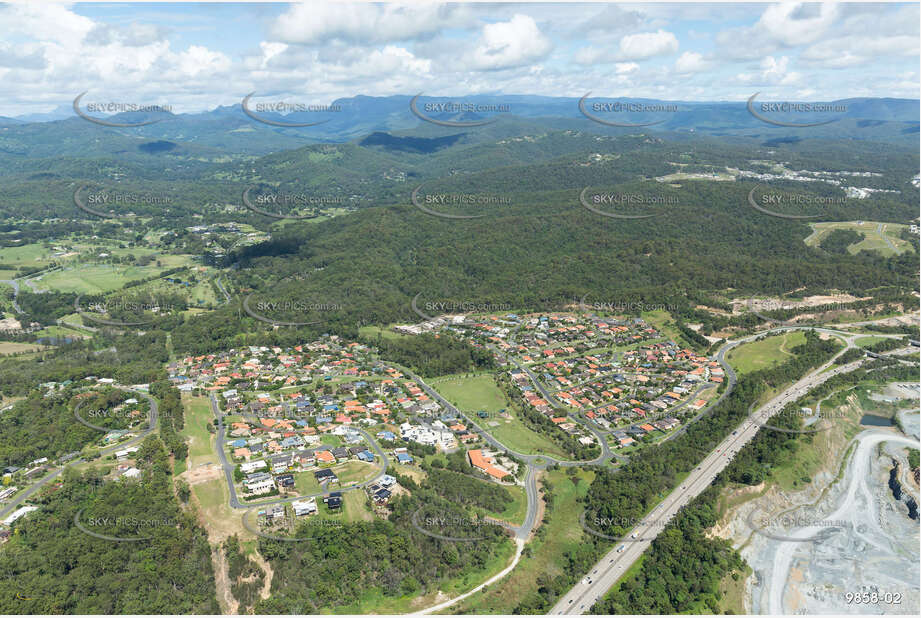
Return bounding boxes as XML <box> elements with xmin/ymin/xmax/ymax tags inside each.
<box><xmin>0</xmin><ymin>95</ymin><xmax>921</xmax><ymax>156</ymax></box>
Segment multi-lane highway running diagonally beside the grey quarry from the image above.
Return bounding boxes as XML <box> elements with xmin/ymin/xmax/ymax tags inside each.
<box><xmin>550</xmin><ymin>344</ymin><xmax>865</xmax><ymax>614</ymax></box>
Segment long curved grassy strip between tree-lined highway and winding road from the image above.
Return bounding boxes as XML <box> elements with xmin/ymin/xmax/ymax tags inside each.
<box><xmin>454</xmin><ymin>469</ymin><xmax>595</xmax><ymax>614</ymax></box>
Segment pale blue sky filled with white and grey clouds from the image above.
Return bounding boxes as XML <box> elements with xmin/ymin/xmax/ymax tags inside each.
<box><xmin>0</xmin><ymin>0</ymin><xmax>921</xmax><ymax>116</ymax></box>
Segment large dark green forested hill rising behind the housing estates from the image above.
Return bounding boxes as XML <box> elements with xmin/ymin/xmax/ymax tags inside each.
<box><xmin>174</xmin><ymin>135</ymin><xmax>918</xmax><ymax>350</ymax></box>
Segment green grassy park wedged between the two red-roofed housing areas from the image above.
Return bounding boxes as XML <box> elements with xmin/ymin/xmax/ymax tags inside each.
<box><xmin>431</xmin><ymin>374</ymin><xmax>568</xmax><ymax>459</ymax></box>
